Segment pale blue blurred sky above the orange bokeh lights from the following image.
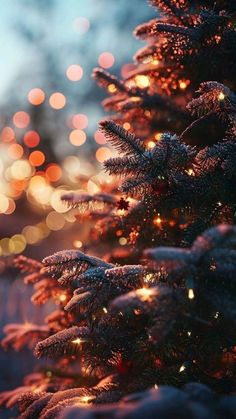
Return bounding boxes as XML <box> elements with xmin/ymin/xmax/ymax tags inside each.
<box><xmin>0</xmin><ymin>0</ymin><xmax>154</xmax><ymax>158</ymax></box>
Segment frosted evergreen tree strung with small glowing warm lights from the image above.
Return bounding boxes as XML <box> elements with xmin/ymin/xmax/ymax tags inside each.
<box><xmin>1</xmin><ymin>0</ymin><xmax>236</xmax><ymax>419</ymax></box>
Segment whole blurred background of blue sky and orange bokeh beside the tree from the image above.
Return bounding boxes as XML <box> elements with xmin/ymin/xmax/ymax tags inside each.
<box><xmin>0</xmin><ymin>0</ymin><xmax>153</xmax><ymax>417</ymax></box>
